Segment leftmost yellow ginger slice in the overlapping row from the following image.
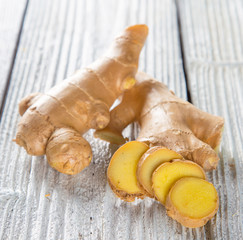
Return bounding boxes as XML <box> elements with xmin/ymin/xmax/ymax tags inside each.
<box><xmin>107</xmin><ymin>141</ymin><xmax>149</xmax><ymax>202</ymax></box>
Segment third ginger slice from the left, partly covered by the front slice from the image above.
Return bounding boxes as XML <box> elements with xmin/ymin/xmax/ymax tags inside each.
<box><xmin>152</xmin><ymin>160</ymin><xmax>206</xmax><ymax>204</ymax></box>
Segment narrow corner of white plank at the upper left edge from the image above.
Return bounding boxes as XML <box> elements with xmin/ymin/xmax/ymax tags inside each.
<box><xmin>0</xmin><ymin>0</ymin><xmax>27</xmax><ymax>106</ymax></box>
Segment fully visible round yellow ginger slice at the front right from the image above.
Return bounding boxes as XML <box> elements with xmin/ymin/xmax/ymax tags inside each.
<box><xmin>166</xmin><ymin>177</ymin><xmax>219</xmax><ymax>228</ymax></box>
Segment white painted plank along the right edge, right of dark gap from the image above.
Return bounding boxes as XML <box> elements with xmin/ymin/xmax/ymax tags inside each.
<box><xmin>178</xmin><ymin>0</ymin><xmax>243</xmax><ymax>239</ymax></box>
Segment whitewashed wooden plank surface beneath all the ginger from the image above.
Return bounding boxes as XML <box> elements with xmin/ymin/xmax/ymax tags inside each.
<box><xmin>0</xmin><ymin>0</ymin><xmax>243</xmax><ymax>240</ymax></box>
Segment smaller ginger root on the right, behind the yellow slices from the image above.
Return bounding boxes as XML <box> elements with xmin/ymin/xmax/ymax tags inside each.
<box><xmin>95</xmin><ymin>72</ymin><xmax>224</xmax><ymax>170</ymax></box>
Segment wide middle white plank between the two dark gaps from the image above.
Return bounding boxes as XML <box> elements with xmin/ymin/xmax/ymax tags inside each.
<box><xmin>0</xmin><ymin>0</ymin><xmax>219</xmax><ymax>240</ymax></box>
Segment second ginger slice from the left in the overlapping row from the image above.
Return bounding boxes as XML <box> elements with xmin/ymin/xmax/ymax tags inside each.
<box><xmin>137</xmin><ymin>147</ymin><xmax>182</xmax><ymax>197</ymax></box>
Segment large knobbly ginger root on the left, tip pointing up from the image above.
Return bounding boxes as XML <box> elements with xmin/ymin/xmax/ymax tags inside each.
<box><xmin>14</xmin><ymin>25</ymin><xmax>148</xmax><ymax>174</ymax></box>
